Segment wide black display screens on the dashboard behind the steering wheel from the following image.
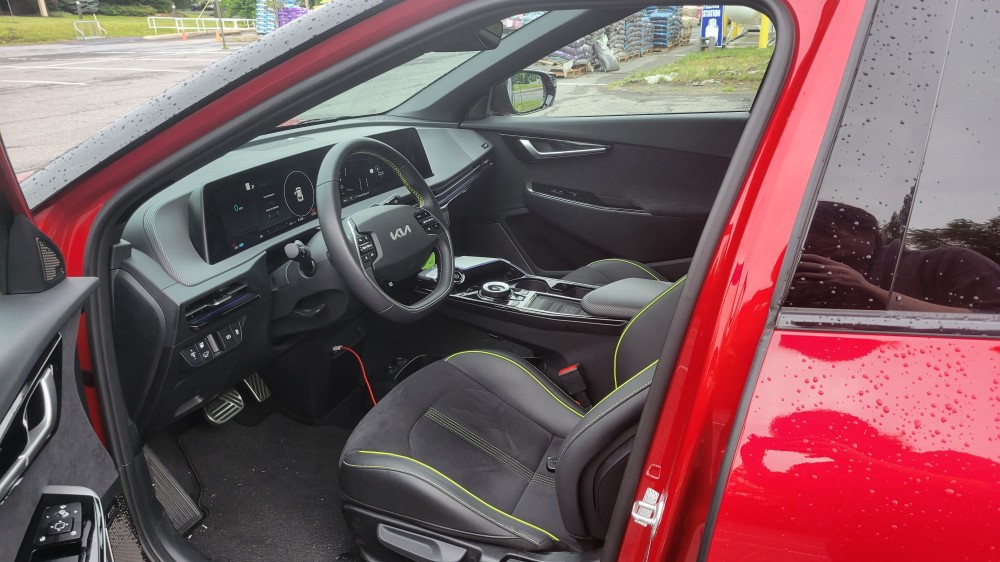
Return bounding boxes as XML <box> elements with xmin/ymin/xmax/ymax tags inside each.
<box><xmin>202</xmin><ymin>128</ymin><xmax>433</xmax><ymax>263</ymax></box>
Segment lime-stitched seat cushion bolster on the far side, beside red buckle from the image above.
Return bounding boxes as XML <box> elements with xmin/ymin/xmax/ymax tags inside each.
<box><xmin>445</xmin><ymin>350</ymin><xmax>583</xmax><ymax>437</ymax></box>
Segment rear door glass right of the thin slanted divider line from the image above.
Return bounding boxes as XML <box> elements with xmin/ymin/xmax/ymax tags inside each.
<box><xmin>892</xmin><ymin>1</ymin><xmax>1000</xmax><ymax>312</ymax></box>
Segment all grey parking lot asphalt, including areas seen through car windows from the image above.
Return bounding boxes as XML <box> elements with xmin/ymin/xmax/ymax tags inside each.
<box><xmin>0</xmin><ymin>34</ymin><xmax>753</xmax><ymax>177</ymax></box>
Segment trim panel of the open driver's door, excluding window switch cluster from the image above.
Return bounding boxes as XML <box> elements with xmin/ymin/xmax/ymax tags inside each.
<box><xmin>0</xmin><ymin>278</ymin><xmax>117</xmax><ymax>560</ymax></box>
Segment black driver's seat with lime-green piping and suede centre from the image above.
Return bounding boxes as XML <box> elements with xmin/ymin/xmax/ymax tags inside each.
<box><xmin>340</xmin><ymin>281</ymin><xmax>683</xmax><ymax>560</ymax></box>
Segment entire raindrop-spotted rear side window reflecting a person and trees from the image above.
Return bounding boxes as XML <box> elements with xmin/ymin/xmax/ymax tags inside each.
<box><xmin>785</xmin><ymin>0</ymin><xmax>1000</xmax><ymax>313</ymax></box>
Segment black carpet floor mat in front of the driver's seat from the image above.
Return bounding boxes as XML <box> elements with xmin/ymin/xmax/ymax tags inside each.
<box><xmin>180</xmin><ymin>414</ymin><xmax>356</xmax><ymax>562</ymax></box>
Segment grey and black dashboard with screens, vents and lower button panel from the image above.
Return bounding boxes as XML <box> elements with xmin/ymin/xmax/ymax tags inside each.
<box><xmin>112</xmin><ymin>122</ymin><xmax>493</xmax><ymax>433</ymax></box>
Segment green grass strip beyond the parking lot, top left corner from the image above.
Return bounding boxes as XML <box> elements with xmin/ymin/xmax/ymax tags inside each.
<box><xmin>0</xmin><ymin>12</ymin><xmax>165</xmax><ymax>45</ymax></box>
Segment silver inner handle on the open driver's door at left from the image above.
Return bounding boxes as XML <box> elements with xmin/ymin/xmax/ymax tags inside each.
<box><xmin>0</xmin><ymin>365</ymin><xmax>59</xmax><ymax>498</ymax></box>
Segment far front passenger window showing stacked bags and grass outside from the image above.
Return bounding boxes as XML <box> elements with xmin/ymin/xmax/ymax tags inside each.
<box><xmin>512</xmin><ymin>6</ymin><xmax>776</xmax><ymax>117</ymax></box>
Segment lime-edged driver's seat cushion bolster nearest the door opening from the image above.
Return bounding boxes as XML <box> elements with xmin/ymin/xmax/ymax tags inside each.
<box><xmin>340</xmin><ymin>451</ymin><xmax>560</xmax><ymax>551</ymax></box>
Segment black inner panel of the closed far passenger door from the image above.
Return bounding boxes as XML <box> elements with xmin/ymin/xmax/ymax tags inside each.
<box><xmin>455</xmin><ymin>113</ymin><xmax>749</xmax><ymax>278</ymax></box>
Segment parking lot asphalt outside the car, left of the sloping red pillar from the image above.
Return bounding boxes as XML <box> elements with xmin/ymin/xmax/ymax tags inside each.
<box><xmin>0</xmin><ymin>39</ymin><xmax>240</xmax><ymax>174</ymax></box>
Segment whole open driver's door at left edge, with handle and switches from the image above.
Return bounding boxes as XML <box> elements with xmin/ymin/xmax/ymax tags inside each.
<box><xmin>0</xmin><ymin>132</ymin><xmax>118</xmax><ymax>562</ymax></box>
